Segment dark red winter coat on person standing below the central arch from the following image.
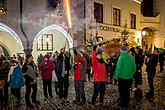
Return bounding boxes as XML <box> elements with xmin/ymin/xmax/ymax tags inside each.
<box><xmin>39</xmin><ymin>56</ymin><xmax>55</xmax><ymax>80</ymax></box>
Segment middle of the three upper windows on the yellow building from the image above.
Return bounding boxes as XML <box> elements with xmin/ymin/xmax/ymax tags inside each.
<box><xmin>113</xmin><ymin>8</ymin><xmax>120</xmax><ymax>26</ymax></box>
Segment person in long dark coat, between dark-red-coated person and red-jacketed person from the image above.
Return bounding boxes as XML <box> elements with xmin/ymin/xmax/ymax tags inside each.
<box><xmin>57</xmin><ymin>48</ymin><xmax>71</xmax><ymax>99</ymax></box>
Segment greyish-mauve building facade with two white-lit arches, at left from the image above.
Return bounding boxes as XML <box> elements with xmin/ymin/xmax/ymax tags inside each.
<box><xmin>0</xmin><ymin>0</ymin><xmax>73</xmax><ymax>59</ymax></box>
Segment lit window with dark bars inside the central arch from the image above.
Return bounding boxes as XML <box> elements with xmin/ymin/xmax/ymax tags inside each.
<box><xmin>37</xmin><ymin>34</ymin><xmax>53</xmax><ymax>51</ymax></box>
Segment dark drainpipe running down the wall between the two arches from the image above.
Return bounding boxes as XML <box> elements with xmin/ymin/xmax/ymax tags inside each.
<box><xmin>20</xmin><ymin>0</ymin><xmax>32</xmax><ymax>54</ymax></box>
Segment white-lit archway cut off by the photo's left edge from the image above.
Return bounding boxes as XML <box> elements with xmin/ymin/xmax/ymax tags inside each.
<box><xmin>0</xmin><ymin>23</ymin><xmax>24</xmax><ymax>57</ymax></box>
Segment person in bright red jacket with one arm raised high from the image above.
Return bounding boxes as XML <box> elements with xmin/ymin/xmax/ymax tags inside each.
<box><xmin>92</xmin><ymin>45</ymin><xmax>108</xmax><ymax>107</ymax></box>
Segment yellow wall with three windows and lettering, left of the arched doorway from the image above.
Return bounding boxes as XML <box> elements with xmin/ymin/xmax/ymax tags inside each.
<box><xmin>87</xmin><ymin>0</ymin><xmax>142</xmax><ymax>46</ymax></box>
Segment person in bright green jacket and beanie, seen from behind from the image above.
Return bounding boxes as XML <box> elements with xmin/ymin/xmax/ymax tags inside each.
<box><xmin>115</xmin><ymin>46</ymin><xmax>136</xmax><ymax>108</ymax></box>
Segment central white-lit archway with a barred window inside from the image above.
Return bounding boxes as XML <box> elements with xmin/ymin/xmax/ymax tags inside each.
<box><xmin>32</xmin><ymin>24</ymin><xmax>73</xmax><ymax>60</ymax></box>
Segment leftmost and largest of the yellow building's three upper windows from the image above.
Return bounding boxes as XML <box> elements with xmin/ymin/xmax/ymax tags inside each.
<box><xmin>94</xmin><ymin>2</ymin><xmax>103</xmax><ymax>23</ymax></box>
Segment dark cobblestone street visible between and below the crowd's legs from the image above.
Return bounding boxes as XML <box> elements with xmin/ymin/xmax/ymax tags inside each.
<box><xmin>1</xmin><ymin>66</ymin><xmax>165</xmax><ymax>110</ymax></box>
